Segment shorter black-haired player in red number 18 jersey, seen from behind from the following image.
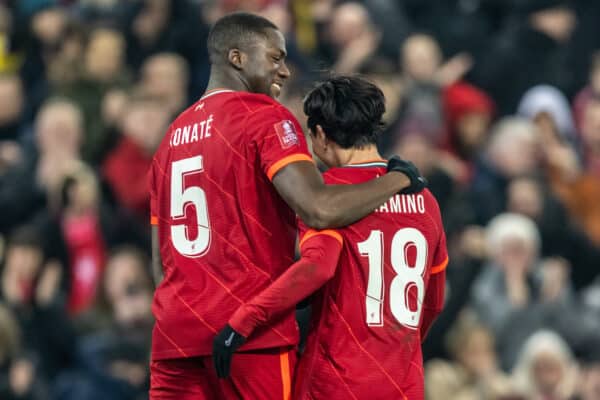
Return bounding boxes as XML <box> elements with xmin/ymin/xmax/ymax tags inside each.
<box><xmin>220</xmin><ymin>77</ymin><xmax>448</xmax><ymax>400</ymax></box>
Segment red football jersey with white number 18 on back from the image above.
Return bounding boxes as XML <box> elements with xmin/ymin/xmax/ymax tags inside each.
<box><xmin>294</xmin><ymin>162</ymin><xmax>448</xmax><ymax>400</ymax></box>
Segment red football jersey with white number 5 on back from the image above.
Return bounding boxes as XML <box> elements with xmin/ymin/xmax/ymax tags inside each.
<box><xmin>149</xmin><ymin>90</ymin><xmax>312</xmax><ymax>359</ymax></box>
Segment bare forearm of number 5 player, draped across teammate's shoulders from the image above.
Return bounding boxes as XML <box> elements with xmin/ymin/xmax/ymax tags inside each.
<box><xmin>308</xmin><ymin>172</ymin><xmax>410</xmax><ymax>229</ymax></box>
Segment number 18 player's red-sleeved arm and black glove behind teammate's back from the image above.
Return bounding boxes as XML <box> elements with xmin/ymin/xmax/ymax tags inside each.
<box><xmin>213</xmin><ymin>231</ymin><xmax>343</xmax><ymax>378</ymax></box>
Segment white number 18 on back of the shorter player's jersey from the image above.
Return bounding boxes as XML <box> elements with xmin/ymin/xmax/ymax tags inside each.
<box><xmin>358</xmin><ymin>228</ymin><xmax>427</xmax><ymax>329</ymax></box>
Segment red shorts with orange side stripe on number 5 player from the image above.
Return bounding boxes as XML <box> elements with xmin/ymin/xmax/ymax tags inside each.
<box><xmin>150</xmin><ymin>348</ymin><xmax>296</xmax><ymax>400</ymax></box>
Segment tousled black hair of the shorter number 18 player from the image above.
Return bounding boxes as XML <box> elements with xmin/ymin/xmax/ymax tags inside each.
<box><xmin>304</xmin><ymin>76</ymin><xmax>385</xmax><ymax>149</ymax></box>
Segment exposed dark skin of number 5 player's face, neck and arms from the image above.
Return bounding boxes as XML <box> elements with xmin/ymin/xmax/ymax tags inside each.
<box><xmin>152</xmin><ymin>29</ymin><xmax>410</xmax><ymax>284</ymax></box>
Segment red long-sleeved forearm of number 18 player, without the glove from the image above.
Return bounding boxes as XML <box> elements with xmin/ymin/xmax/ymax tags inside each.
<box><xmin>229</xmin><ymin>238</ymin><xmax>341</xmax><ymax>337</ymax></box>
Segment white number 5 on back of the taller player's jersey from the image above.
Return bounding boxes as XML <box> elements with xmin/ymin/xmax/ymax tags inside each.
<box><xmin>171</xmin><ymin>156</ymin><xmax>210</xmax><ymax>257</ymax></box>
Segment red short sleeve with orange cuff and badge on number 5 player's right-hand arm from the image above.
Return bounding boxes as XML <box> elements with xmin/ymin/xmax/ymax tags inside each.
<box><xmin>246</xmin><ymin>104</ymin><xmax>313</xmax><ymax>180</ymax></box>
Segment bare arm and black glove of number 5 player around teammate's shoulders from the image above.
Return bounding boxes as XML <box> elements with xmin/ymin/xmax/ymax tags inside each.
<box><xmin>273</xmin><ymin>158</ymin><xmax>425</xmax><ymax>229</ymax></box>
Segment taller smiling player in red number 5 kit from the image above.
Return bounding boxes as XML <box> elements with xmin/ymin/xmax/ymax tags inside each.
<box><xmin>149</xmin><ymin>13</ymin><xmax>423</xmax><ymax>400</ymax></box>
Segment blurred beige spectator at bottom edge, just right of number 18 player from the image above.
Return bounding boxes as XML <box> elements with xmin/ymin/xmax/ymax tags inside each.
<box><xmin>425</xmin><ymin>313</ymin><xmax>511</xmax><ymax>400</ymax></box>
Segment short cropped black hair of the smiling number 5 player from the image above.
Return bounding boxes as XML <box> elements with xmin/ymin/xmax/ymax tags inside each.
<box><xmin>207</xmin><ymin>12</ymin><xmax>278</xmax><ymax>64</ymax></box>
